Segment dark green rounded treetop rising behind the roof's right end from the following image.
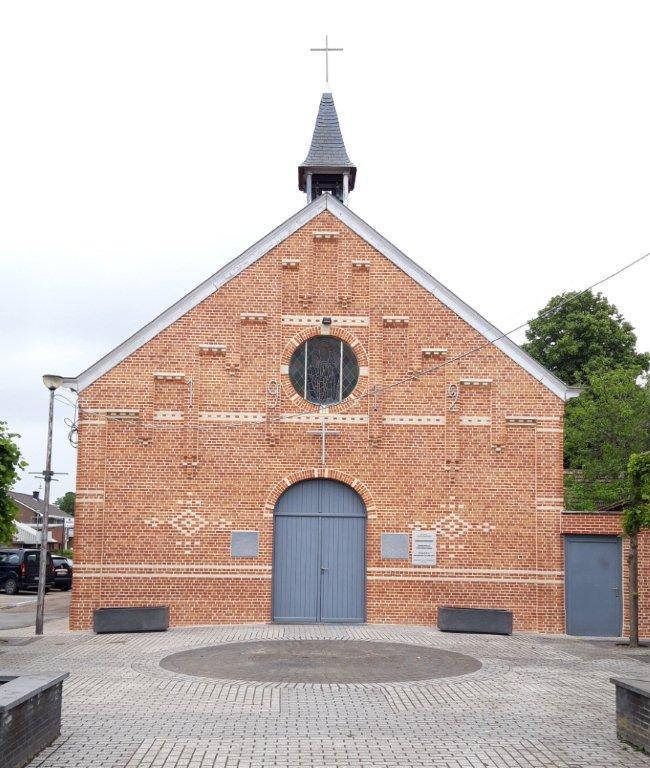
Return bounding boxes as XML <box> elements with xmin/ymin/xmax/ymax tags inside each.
<box><xmin>522</xmin><ymin>291</ymin><xmax>650</xmax><ymax>385</ymax></box>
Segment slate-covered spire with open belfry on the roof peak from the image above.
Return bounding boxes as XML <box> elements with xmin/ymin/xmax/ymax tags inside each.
<box><xmin>298</xmin><ymin>86</ymin><xmax>357</xmax><ymax>205</ymax></box>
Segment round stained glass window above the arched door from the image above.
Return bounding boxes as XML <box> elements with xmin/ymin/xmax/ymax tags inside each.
<box><xmin>289</xmin><ymin>336</ymin><xmax>359</xmax><ymax>405</ymax></box>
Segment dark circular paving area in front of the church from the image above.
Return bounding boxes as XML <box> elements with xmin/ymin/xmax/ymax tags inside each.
<box><xmin>160</xmin><ymin>640</ymin><xmax>481</xmax><ymax>683</ymax></box>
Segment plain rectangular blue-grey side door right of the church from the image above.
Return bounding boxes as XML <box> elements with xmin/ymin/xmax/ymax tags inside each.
<box><xmin>564</xmin><ymin>535</ymin><xmax>623</xmax><ymax>637</ymax></box>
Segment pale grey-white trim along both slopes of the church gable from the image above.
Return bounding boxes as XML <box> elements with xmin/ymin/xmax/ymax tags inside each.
<box><xmin>64</xmin><ymin>195</ymin><xmax>580</xmax><ymax>400</ymax></box>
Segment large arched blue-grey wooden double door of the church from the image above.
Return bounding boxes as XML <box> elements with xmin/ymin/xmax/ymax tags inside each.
<box><xmin>273</xmin><ymin>480</ymin><xmax>366</xmax><ymax>623</ymax></box>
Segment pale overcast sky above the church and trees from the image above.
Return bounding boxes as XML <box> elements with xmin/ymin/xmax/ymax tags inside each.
<box><xmin>0</xmin><ymin>0</ymin><xmax>650</xmax><ymax>497</ymax></box>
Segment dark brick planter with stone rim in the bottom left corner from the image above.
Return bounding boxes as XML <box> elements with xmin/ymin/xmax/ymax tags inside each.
<box><xmin>0</xmin><ymin>672</ymin><xmax>69</xmax><ymax>768</ymax></box>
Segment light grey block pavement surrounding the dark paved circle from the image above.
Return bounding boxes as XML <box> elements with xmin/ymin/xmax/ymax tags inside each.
<box><xmin>0</xmin><ymin>622</ymin><xmax>650</xmax><ymax>768</ymax></box>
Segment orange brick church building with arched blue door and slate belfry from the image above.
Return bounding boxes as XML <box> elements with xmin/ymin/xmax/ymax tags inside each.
<box><xmin>68</xmin><ymin>87</ymin><xmax>644</xmax><ymax>632</ymax></box>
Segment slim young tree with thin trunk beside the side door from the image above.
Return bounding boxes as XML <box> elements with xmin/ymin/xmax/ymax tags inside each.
<box><xmin>623</xmin><ymin>452</ymin><xmax>650</xmax><ymax>648</ymax></box>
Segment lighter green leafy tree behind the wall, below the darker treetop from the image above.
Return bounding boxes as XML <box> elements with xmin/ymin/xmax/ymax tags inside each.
<box><xmin>564</xmin><ymin>368</ymin><xmax>650</xmax><ymax>509</ymax></box>
